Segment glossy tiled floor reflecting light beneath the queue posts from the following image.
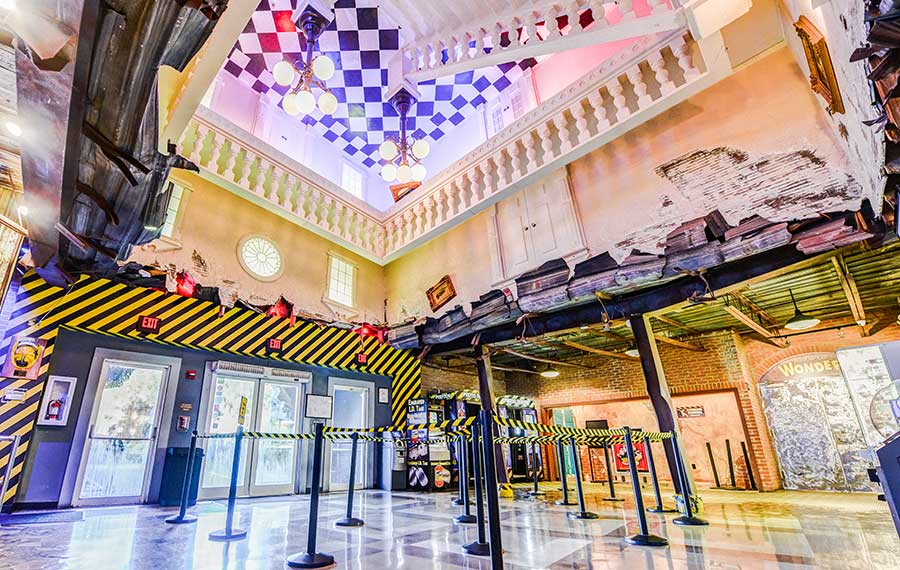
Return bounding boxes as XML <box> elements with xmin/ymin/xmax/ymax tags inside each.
<box><xmin>0</xmin><ymin>484</ymin><xmax>900</xmax><ymax>570</ymax></box>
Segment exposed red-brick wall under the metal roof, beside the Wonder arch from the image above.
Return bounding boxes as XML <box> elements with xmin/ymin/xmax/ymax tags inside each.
<box><xmin>507</xmin><ymin>331</ymin><xmax>781</xmax><ymax>490</ymax></box>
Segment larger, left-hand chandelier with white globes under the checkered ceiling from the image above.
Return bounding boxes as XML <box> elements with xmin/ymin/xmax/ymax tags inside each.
<box><xmin>272</xmin><ymin>9</ymin><xmax>337</xmax><ymax>115</ymax></box>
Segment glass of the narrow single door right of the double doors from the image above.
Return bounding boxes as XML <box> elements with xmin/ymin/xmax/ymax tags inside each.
<box><xmin>328</xmin><ymin>385</ymin><xmax>370</xmax><ymax>491</ymax></box>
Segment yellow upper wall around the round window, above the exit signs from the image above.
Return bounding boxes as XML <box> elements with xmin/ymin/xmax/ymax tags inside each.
<box><xmin>131</xmin><ymin>171</ymin><xmax>385</xmax><ymax>321</ymax></box>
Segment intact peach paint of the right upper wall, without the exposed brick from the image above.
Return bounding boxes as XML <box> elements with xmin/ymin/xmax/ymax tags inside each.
<box><xmin>386</xmin><ymin>47</ymin><xmax>847</xmax><ymax>320</ymax></box>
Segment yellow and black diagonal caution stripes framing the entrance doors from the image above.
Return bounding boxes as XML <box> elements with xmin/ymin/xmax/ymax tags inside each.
<box><xmin>0</xmin><ymin>272</ymin><xmax>421</xmax><ymax>506</ymax></box>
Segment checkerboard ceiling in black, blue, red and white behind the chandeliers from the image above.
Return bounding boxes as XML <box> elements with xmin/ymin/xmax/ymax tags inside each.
<box><xmin>225</xmin><ymin>0</ymin><xmax>535</xmax><ymax>172</ymax></box>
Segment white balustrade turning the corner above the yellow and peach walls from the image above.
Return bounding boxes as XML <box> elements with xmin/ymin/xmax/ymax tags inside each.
<box><xmin>181</xmin><ymin>34</ymin><xmax>704</xmax><ymax>263</ymax></box>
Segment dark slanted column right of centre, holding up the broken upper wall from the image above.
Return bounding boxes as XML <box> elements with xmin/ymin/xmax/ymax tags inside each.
<box><xmin>628</xmin><ymin>315</ymin><xmax>692</xmax><ymax>493</ymax></box>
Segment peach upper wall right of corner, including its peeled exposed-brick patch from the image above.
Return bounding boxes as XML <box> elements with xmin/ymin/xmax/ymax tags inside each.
<box><xmin>386</xmin><ymin>47</ymin><xmax>864</xmax><ymax>321</ymax></box>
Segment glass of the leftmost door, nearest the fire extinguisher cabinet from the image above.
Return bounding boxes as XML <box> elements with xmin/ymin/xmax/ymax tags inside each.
<box><xmin>74</xmin><ymin>359</ymin><xmax>169</xmax><ymax>505</ymax></box>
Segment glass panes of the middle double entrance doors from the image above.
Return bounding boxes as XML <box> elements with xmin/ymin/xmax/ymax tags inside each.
<box><xmin>200</xmin><ymin>374</ymin><xmax>302</xmax><ymax>499</ymax></box>
